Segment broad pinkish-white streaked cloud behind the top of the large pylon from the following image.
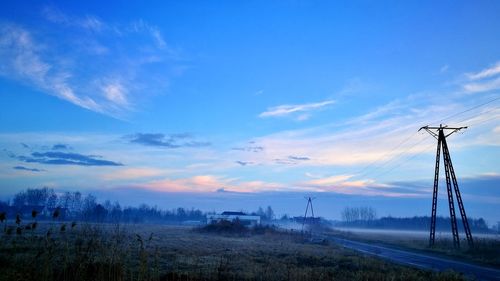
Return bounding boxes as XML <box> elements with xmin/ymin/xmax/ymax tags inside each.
<box><xmin>238</xmin><ymin>71</ymin><xmax>500</xmax><ymax>174</ymax></box>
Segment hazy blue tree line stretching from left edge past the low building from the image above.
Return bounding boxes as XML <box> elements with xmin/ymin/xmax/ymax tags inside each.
<box><xmin>0</xmin><ymin>187</ymin><xmax>274</xmax><ymax>223</ymax></box>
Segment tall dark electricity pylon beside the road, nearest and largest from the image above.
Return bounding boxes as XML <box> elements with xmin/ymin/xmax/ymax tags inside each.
<box><xmin>419</xmin><ymin>124</ymin><xmax>474</xmax><ymax>248</ymax></box>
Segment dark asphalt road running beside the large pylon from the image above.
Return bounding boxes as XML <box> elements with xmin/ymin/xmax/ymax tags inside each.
<box><xmin>328</xmin><ymin>236</ymin><xmax>500</xmax><ymax>280</ymax></box>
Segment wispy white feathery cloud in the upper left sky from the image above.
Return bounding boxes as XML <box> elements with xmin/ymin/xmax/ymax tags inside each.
<box><xmin>0</xmin><ymin>7</ymin><xmax>183</xmax><ymax>118</ymax></box>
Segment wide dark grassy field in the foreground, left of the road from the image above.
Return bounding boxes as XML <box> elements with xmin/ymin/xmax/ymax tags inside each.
<box><xmin>0</xmin><ymin>221</ymin><xmax>468</xmax><ymax>281</ymax></box>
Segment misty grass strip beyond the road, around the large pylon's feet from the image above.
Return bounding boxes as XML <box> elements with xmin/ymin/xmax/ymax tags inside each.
<box><xmin>330</xmin><ymin>228</ymin><xmax>500</xmax><ymax>268</ymax></box>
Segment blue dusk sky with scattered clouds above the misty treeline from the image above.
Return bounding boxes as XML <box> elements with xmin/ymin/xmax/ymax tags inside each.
<box><xmin>0</xmin><ymin>1</ymin><xmax>500</xmax><ymax>222</ymax></box>
